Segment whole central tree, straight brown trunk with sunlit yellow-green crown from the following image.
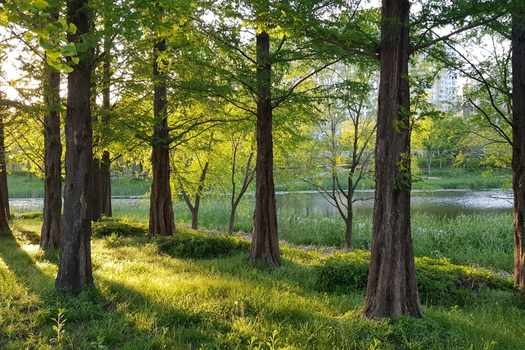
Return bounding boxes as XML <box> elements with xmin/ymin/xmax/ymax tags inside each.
<box><xmin>196</xmin><ymin>0</ymin><xmax>340</xmax><ymax>267</ymax></box>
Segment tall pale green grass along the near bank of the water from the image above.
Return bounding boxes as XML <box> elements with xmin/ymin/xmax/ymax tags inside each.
<box><xmin>109</xmin><ymin>198</ymin><xmax>514</xmax><ymax>272</ymax></box>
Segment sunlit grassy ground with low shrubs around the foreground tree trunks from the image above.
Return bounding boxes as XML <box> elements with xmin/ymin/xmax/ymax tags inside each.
<box><xmin>0</xmin><ymin>216</ymin><xmax>525</xmax><ymax>350</ymax></box>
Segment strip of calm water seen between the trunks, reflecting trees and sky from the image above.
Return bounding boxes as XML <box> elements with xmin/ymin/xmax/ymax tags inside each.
<box><xmin>9</xmin><ymin>190</ymin><xmax>512</xmax><ymax>216</ymax></box>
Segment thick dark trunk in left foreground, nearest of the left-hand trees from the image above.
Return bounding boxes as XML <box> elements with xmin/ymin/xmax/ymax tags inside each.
<box><xmin>56</xmin><ymin>0</ymin><xmax>93</xmax><ymax>293</ymax></box>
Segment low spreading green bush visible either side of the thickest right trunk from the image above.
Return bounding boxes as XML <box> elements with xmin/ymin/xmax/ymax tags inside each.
<box><xmin>317</xmin><ymin>250</ymin><xmax>513</xmax><ymax>305</ymax></box>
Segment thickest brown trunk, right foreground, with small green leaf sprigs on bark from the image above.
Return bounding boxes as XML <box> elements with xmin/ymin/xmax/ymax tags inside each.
<box><xmin>364</xmin><ymin>0</ymin><xmax>421</xmax><ymax>318</ymax></box>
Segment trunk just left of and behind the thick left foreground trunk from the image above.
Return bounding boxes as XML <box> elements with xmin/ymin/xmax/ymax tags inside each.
<box><xmin>40</xmin><ymin>56</ymin><xmax>62</xmax><ymax>249</ymax></box>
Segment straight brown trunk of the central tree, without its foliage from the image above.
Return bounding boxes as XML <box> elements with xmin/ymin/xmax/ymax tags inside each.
<box><xmin>250</xmin><ymin>31</ymin><xmax>280</xmax><ymax>267</ymax></box>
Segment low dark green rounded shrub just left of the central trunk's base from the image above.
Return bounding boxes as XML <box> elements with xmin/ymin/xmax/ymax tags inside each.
<box><xmin>158</xmin><ymin>233</ymin><xmax>250</xmax><ymax>259</ymax></box>
